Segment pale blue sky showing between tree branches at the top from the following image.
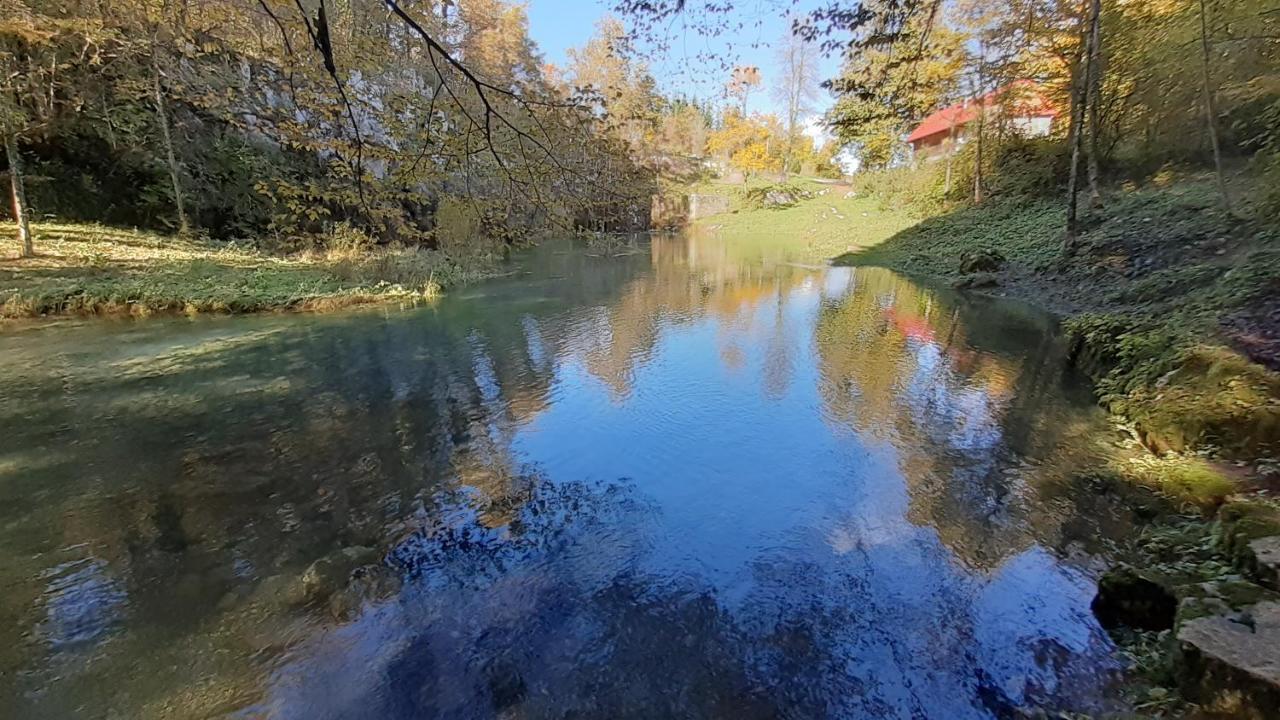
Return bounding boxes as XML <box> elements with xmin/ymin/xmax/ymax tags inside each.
<box><xmin>526</xmin><ymin>0</ymin><xmax>840</xmax><ymax>119</ymax></box>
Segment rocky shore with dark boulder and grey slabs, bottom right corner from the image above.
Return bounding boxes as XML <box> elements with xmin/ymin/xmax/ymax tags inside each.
<box><xmin>1093</xmin><ymin>500</ymin><xmax>1280</xmax><ymax>720</ymax></box>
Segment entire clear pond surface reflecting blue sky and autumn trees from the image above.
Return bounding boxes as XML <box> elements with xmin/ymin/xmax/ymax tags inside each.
<box><xmin>0</xmin><ymin>233</ymin><xmax>1136</xmax><ymax>720</ymax></box>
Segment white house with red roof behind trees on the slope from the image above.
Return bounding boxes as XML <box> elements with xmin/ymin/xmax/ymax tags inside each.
<box><xmin>906</xmin><ymin>79</ymin><xmax>1059</xmax><ymax>160</ymax></box>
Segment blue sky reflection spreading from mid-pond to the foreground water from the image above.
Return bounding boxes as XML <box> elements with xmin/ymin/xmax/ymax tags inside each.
<box><xmin>254</xmin><ymin>254</ymin><xmax>1110</xmax><ymax>719</ymax></box>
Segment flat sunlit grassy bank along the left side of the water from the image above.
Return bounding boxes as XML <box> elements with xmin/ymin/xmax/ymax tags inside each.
<box><xmin>0</xmin><ymin>223</ymin><xmax>493</xmax><ymax>319</ymax></box>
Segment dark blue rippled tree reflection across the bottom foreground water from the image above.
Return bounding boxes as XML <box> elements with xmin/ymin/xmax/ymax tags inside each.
<box><xmin>270</xmin><ymin>466</ymin><xmax>1107</xmax><ymax>719</ymax></box>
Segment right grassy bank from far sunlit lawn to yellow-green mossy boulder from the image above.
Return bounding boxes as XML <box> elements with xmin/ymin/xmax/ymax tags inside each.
<box><xmin>699</xmin><ymin>176</ymin><xmax>1280</xmax><ymax>499</ymax></box>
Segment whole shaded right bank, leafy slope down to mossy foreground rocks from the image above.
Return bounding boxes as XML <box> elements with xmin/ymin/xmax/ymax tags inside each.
<box><xmin>836</xmin><ymin>172</ymin><xmax>1280</xmax><ymax>719</ymax></box>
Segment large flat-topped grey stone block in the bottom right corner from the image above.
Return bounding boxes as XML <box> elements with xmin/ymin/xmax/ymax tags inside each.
<box><xmin>1178</xmin><ymin>601</ymin><xmax>1280</xmax><ymax>720</ymax></box>
